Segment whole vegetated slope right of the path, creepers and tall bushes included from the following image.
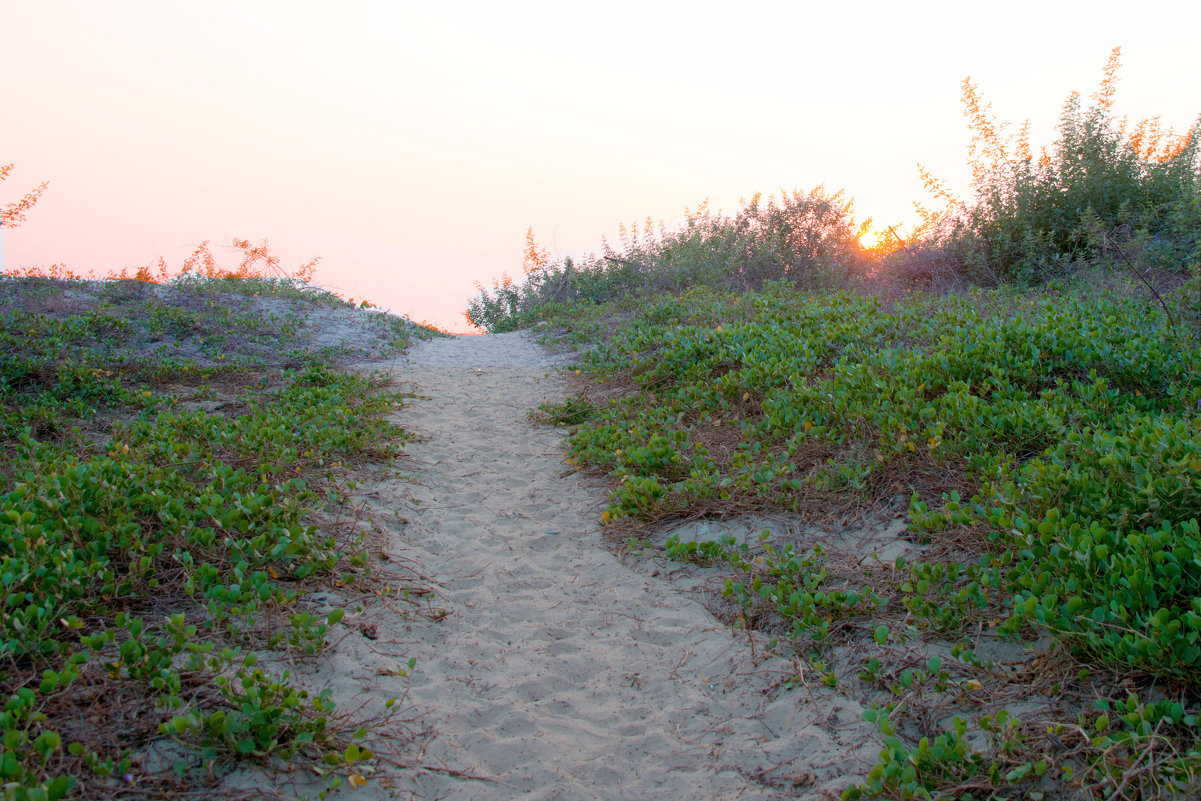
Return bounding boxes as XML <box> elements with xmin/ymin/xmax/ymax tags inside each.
<box><xmin>467</xmin><ymin>53</ymin><xmax>1201</xmax><ymax>800</ymax></box>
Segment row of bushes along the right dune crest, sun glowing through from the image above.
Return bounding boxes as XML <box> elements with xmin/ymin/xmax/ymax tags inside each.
<box><xmin>466</xmin><ymin>49</ymin><xmax>1201</xmax><ymax>331</ymax></box>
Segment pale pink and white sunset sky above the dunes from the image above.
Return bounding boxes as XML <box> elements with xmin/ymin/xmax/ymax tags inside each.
<box><xmin>0</xmin><ymin>0</ymin><xmax>1201</xmax><ymax>330</ymax></box>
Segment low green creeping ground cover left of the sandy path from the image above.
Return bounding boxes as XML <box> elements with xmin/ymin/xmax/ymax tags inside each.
<box><xmin>0</xmin><ymin>276</ymin><xmax>432</xmax><ymax>801</ymax></box>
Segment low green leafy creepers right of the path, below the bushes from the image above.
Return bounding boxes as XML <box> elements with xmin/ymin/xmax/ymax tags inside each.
<box><xmin>545</xmin><ymin>281</ymin><xmax>1201</xmax><ymax>797</ymax></box>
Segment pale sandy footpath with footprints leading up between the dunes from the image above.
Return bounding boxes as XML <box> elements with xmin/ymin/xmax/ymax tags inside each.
<box><xmin>331</xmin><ymin>334</ymin><xmax>879</xmax><ymax>801</ymax></box>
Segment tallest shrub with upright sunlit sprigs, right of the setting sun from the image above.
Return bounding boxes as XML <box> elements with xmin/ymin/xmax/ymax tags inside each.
<box><xmin>896</xmin><ymin>49</ymin><xmax>1201</xmax><ymax>283</ymax></box>
